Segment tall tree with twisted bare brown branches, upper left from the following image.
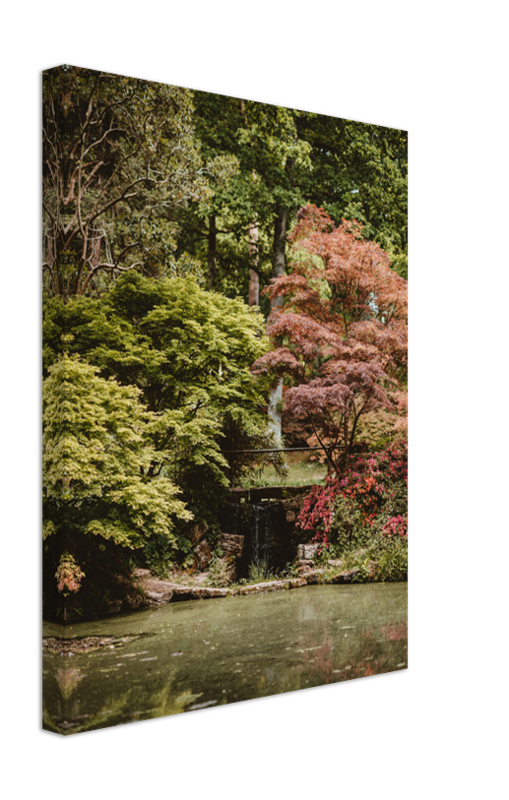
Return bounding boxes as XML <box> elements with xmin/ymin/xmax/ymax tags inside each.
<box><xmin>42</xmin><ymin>65</ymin><xmax>208</xmax><ymax>299</ymax></box>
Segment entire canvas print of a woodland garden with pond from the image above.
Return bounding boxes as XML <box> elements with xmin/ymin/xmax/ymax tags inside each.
<box><xmin>42</xmin><ymin>64</ymin><xmax>408</xmax><ymax>736</ymax></box>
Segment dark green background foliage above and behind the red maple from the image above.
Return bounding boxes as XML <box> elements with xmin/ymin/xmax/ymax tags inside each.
<box><xmin>173</xmin><ymin>97</ymin><xmax>408</xmax><ymax>302</ymax></box>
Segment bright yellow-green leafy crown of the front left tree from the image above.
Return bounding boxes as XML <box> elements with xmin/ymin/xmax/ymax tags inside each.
<box><xmin>42</xmin><ymin>353</ymin><xmax>192</xmax><ymax>551</ymax></box>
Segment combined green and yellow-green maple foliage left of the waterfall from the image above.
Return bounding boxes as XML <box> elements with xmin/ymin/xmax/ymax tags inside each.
<box><xmin>43</xmin><ymin>272</ymin><xmax>278</xmax><ymax>604</ymax></box>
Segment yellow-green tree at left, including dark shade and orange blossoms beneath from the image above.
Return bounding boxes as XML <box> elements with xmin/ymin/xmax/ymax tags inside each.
<box><xmin>42</xmin><ymin>350</ymin><xmax>193</xmax><ymax>622</ymax></box>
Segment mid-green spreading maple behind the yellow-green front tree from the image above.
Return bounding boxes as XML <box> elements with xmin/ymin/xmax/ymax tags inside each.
<box><xmin>43</xmin><ymin>272</ymin><xmax>284</xmax><ymax>522</ymax></box>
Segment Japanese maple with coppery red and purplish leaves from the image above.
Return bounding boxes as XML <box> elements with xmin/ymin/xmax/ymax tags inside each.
<box><xmin>252</xmin><ymin>205</ymin><xmax>408</xmax><ymax>473</ymax></box>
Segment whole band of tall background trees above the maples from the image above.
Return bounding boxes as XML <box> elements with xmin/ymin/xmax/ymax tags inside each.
<box><xmin>42</xmin><ymin>65</ymin><xmax>408</xmax><ymax>306</ymax></box>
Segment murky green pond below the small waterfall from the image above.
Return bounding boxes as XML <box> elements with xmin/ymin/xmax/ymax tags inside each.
<box><xmin>43</xmin><ymin>582</ymin><xmax>408</xmax><ymax>734</ymax></box>
